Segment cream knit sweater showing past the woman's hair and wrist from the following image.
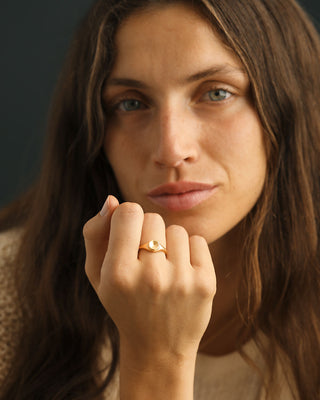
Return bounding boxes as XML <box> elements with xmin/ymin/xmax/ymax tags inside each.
<box><xmin>0</xmin><ymin>231</ymin><xmax>293</xmax><ymax>400</ymax></box>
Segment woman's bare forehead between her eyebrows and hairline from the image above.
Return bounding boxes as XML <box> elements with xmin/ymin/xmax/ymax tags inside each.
<box><xmin>111</xmin><ymin>4</ymin><xmax>242</xmax><ymax>84</ymax></box>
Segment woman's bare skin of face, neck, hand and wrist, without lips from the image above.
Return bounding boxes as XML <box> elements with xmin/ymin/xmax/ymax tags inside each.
<box><xmin>84</xmin><ymin>5</ymin><xmax>266</xmax><ymax>400</ymax></box>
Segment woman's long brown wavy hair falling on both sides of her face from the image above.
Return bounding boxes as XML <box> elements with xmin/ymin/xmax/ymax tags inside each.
<box><xmin>0</xmin><ymin>0</ymin><xmax>320</xmax><ymax>400</ymax></box>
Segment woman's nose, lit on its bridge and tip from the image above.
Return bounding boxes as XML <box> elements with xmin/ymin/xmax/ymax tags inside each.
<box><xmin>153</xmin><ymin>107</ymin><xmax>199</xmax><ymax>168</ymax></box>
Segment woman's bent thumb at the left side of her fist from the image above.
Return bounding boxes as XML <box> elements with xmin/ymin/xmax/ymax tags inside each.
<box><xmin>83</xmin><ymin>195</ymin><xmax>119</xmax><ymax>288</ymax></box>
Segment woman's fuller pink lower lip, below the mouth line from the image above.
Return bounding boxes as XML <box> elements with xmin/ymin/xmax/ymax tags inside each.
<box><xmin>149</xmin><ymin>187</ymin><xmax>216</xmax><ymax>211</ymax></box>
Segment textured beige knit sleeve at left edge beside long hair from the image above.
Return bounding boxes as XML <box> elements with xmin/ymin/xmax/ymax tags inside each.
<box><xmin>0</xmin><ymin>231</ymin><xmax>21</xmax><ymax>387</ymax></box>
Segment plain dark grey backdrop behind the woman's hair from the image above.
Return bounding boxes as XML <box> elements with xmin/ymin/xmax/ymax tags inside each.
<box><xmin>0</xmin><ymin>0</ymin><xmax>320</xmax><ymax>207</ymax></box>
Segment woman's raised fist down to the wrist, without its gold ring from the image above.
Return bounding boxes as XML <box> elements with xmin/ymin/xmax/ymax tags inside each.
<box><xmin>83</xmin><ymin>196</ymin><xmax>216</xmax><ymax>364</ymax></box>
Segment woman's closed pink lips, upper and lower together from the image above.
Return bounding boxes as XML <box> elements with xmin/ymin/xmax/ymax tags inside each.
<box><xmin>148</xmin><ymin>181</ymin><xmax>217</xmax><ymax>211</ymax></box>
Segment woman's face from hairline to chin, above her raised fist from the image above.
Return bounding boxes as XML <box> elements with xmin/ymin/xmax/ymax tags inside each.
<box><xmin>104</xmin><ymin>4</ymin><xmax>266</xmax><ymax>243</ymax></box>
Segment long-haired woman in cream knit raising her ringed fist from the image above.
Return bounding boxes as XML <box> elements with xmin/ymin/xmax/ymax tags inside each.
<box><xmin>1</xmin><ymin>0</ymin><xmax>320</xmax><ymax>400</ymax></box>
